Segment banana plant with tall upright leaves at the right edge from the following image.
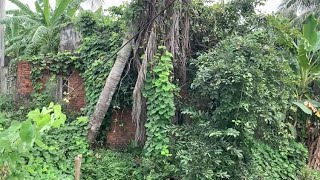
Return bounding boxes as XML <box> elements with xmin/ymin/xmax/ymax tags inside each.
<box><xmin>290</xmin><ymin>14</ymin><xmax>320</xmax><ymax>139</ymax></box>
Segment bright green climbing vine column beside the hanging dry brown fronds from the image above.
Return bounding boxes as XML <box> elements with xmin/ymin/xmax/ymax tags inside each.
<box><xmin>144</xmin><ymin>46</ymin><xmax>176</xmax><ymax>158</ymax></box>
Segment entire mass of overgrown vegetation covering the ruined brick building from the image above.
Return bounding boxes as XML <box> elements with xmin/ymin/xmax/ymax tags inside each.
<box><xmin>0</xmin><ymin>0</ymin><xmax>320</xmax><ymax>180</ymax></box>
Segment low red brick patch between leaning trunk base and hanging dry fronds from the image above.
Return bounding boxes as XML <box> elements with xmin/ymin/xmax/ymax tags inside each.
<box><xmin>107</xmin><ymin>109</ymin><xmax>136</xmax><ymax>148</ymax></box>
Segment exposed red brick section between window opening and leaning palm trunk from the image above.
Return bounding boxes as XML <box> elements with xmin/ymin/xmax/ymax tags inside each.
<box><xmin>68</xmin><ymin>71</ymin><xmax>86</xmax><ymax>111</ymax></box>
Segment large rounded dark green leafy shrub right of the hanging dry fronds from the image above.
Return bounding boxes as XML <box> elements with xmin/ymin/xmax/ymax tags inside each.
<box><xmin>192</xmin><ymin>31</ymin><xmax>295</xmax><ymax>144</ymax></box>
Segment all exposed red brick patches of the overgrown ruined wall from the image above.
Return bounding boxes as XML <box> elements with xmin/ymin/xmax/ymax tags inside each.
<box><xmin>16</xmin><ymin>61</ymin><xmax>136</xmax><ymax>146</ymax></box>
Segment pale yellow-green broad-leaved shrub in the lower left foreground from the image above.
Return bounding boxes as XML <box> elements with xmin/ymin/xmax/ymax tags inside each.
<box><xmin>0</xmin><ymin>103</ymin><xmax>66</xmax><ymax>179</ymax></box>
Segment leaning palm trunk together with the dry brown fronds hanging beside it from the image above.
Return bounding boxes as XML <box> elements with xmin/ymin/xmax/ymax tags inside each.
<box><xmin>88</xmin><ymin>0</ymin><xmax>189</xmax><ymax>143</ymax></box>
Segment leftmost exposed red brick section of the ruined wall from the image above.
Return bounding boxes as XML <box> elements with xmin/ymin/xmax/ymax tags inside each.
<box><xmin>16</xmin><ymin>61</ymin><xmax>33</xmax><ymax>96</ymax></box>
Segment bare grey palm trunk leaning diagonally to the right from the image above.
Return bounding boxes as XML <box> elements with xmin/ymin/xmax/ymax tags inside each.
<box><xmin>87</xmin><ymin>25</ymin><xmax>136</xmax><ymax>144</ymax></box>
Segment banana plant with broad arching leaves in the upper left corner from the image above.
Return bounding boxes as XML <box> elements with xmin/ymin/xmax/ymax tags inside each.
<box><xmin>0</xmin><ymin>0</ymin><xmax>82</xmax><ymax>54</ymax></box>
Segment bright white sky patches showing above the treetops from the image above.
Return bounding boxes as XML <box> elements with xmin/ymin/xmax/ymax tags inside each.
<box><xmin>6</xmin><ymin>0</ymin><xmax>281</xmax><ymax>13</ymax></box>
